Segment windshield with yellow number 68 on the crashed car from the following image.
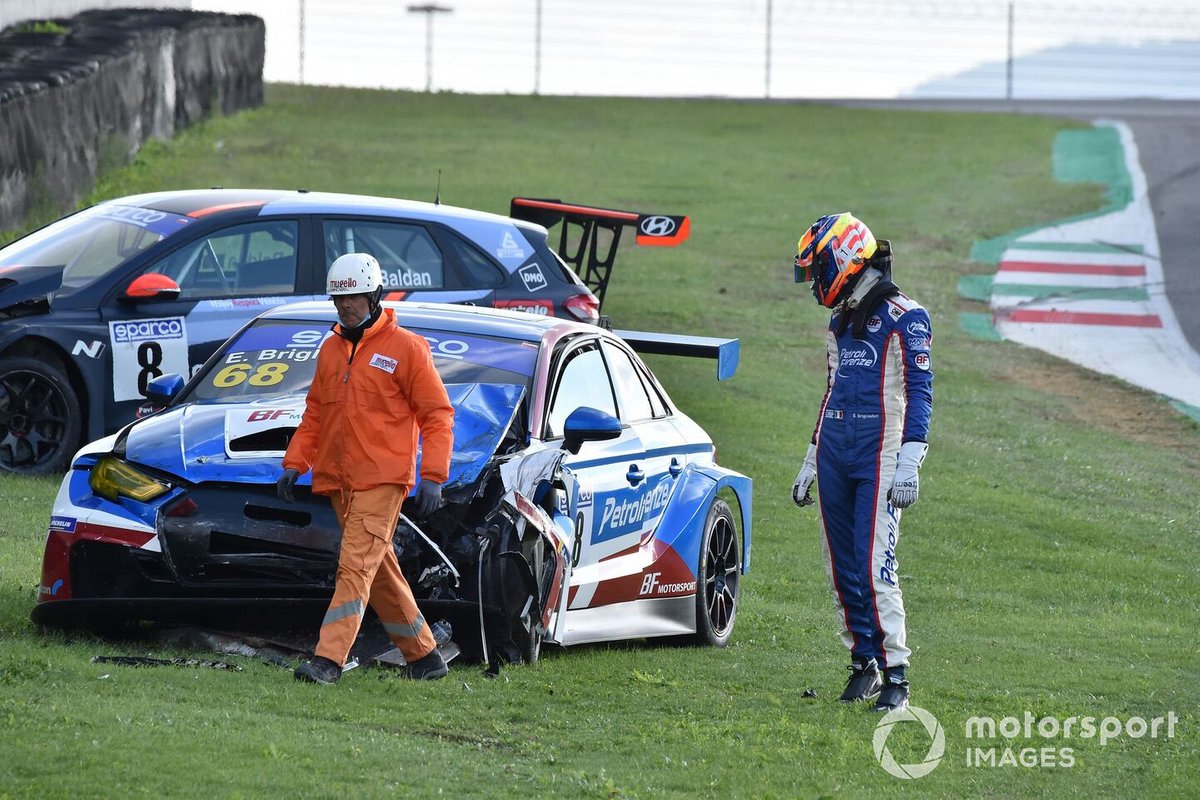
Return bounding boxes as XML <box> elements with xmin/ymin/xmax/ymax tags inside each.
<box><xmin>180</xmin><ymin>319</ymin><xmax>538</xmax><ymax>403</ymax></box>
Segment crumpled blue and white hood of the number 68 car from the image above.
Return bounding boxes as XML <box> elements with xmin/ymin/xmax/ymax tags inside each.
<box><xmin>124</xmin><ymin>384</ymin><xmax>524</xmax><ymax>487</ymax></box>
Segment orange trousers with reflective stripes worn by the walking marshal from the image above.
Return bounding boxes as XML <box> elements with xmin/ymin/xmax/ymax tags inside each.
<box><xmin>316</xmin><ymin>485</ymin><xmax>437</xmax><ymax>664</ymax></box>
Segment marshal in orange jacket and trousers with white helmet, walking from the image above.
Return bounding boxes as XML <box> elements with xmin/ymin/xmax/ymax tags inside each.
<box><xmin>276</xmin><ymin>253</ymin><xmax>454</xmax><ymax>684</ymax></box>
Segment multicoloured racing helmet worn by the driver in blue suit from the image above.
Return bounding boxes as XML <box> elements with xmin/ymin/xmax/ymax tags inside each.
<box><xmin>794</xmin><ymin>211</ymin><xmax>878</xmax><ymax>308</ymax></box>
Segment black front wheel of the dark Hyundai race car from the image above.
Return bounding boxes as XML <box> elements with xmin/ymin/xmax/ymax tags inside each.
<box><xmin>0</xmin><ymin>356</ymin><xmax>83</xmax><ymax>475</ymax></box>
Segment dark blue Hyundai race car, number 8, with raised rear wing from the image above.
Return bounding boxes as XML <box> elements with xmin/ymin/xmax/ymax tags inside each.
<box><xmin>0</xmin><ymin>190</ymin><xmax>688</xmax><ymax>474</ymax></box>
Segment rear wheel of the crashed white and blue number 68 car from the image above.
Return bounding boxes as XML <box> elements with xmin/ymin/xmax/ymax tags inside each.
<box><xmin>691</xmin><ymin>498</ymin><xmax>742</xmax><ymax>648</ymax></box>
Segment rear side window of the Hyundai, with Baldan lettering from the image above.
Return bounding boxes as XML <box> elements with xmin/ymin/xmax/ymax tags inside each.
<box><xmin>324</xmin><ymin>219</ymin><xmax>445</xmax><ymax>291</ymax></box>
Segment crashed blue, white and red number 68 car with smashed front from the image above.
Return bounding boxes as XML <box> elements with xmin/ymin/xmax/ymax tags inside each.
<box><xmin>32</xmin><ymin>302</ymin><xmax>752</xmax><ymax>663</ymax></box>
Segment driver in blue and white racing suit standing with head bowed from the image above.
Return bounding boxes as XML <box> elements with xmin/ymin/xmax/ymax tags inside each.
<box><xmin>792</xmin><ymin>212</ymin><xmax>934</xmax><ymax>711</ymax></box>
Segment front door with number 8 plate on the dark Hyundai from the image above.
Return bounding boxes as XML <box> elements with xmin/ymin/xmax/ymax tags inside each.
<box><xmin>104</xmin><ymin>217</ymin><xmax>309</xmax><ymax>419</ymax></box>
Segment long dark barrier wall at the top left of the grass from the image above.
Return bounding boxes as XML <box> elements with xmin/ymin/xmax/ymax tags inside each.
<box><xmin>0</xmin><ymin>8</ymin><xmax>265</xmax><ymax>230</ymax></box>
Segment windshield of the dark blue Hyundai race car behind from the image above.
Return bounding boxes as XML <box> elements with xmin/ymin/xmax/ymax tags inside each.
<box><xmin>0</xmin><ymin>204</ymin><xmax>192</xmax><ymax>294</ymax></box>
